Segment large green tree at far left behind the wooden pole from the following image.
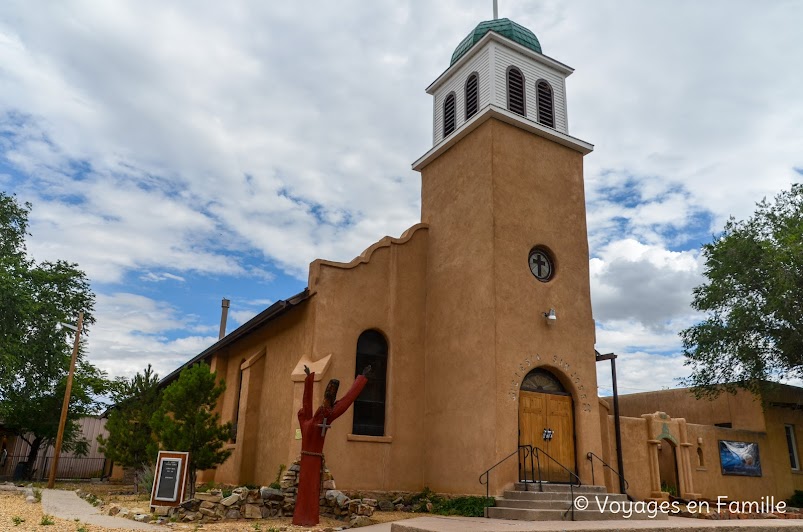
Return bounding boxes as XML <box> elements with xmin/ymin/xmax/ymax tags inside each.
<box><xmin>0</xmin><ymin>192</ymin><xmax>108</xmax><ymax>475</ymax></box>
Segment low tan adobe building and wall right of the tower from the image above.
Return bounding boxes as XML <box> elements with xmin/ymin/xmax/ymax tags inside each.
<box><xmin>600</xmin><ymin>384</ymin><xmax>803</xmax><ymax>501</ymax></box>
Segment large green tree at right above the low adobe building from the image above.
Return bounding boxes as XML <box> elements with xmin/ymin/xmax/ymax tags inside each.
<box><xmin>681</xmin><ymin>184</ymin><xmax>803</xmax><ymax>396</ymax></box>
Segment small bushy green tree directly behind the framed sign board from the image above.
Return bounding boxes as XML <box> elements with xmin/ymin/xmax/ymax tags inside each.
<box><xmin>151</xmin><ymin>363</ymin><xmax>231</xmax><ymax>496</ymax></box>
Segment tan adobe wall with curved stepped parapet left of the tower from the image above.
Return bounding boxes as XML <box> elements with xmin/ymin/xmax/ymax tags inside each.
<box><xmin>302</xmin><ymin>224</ymin><xmax>428</xmax><ymax>490</ymax></box>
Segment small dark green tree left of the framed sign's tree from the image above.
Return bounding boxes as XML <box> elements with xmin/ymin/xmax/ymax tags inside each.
<box><xmin>98</xmin><ymin>364</ymin><xmax>161</xmax><ymax>488</ymax></box>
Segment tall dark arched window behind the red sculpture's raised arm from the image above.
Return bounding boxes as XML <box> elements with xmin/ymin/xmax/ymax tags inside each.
<box><xmin>351</xmin><ymin>330</ymin><xmax>388</xmax><ymax>436</ymax></box>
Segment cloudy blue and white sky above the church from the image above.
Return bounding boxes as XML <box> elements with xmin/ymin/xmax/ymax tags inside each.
<box><xmin>0</xmin><ymin>0</ymin><xmax>803</xmax><ymax>393</ymax></box>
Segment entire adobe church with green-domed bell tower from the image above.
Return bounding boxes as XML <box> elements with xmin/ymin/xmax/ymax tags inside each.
<box><xmin>163</xmin><ymin>13</ymin><xmax>803</xmax><ymax>498</ymax></box>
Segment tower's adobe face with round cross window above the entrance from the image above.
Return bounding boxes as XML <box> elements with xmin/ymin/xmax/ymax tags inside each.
<box><xmin>490</xmin><ymin>121</ymin><xmax>601</xmax><ymax>490</ymax></box>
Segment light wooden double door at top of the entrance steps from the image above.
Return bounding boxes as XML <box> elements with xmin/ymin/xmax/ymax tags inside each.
<box><xmin>519</xmin><ymin>390</ymin><xmax>577</xmax><ymax>482</ymax></box>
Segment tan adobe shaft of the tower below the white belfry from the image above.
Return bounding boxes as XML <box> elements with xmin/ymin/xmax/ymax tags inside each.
<box><xmin>422</xmin><ymin>119</ymin><xmax>601</xmax><ymax>493</ymax></box>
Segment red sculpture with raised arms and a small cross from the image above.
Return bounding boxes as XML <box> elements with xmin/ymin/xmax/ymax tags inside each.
<box><xmin>293</xmin><ymin>366</ymin><xmax>371</xmax><ymax>526</ymax></box>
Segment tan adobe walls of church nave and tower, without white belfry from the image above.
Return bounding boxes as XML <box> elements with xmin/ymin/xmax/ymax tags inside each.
<box><xmin>193</xmin><ymin>111</ymin><xmax>602</xmax><ymax>493</ymax></box>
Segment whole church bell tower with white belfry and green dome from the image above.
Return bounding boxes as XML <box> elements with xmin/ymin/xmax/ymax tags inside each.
<box><xmin>413</xmin><ymin>15</ymin><xmax>601</xmax><ymax>493</ymax></box>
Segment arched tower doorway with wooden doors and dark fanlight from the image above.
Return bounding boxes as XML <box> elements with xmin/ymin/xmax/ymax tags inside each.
<box><xmin>519</xmin><ymin>368</ymin><xmax>576</xmax><ymax>482</ymax></box>
